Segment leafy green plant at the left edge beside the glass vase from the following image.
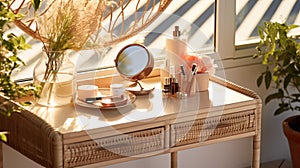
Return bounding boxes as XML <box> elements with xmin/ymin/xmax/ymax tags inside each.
<box><xmin>0</xmin><ymin>0</ymin><xmax>36</xmax><ymax>140</ymax></box>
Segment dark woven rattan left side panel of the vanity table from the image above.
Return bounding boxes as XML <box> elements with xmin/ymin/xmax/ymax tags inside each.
<box><xmin>0</xmin><ymin>100</ymin><xmax>62</xmax><ymax>167</ymax></box>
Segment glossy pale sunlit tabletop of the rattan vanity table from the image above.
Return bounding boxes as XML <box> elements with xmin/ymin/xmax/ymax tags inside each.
<box><xmin>29</xmin><ymin>77</ymin><xmax>253</xmax><ymax>134</ymax></box>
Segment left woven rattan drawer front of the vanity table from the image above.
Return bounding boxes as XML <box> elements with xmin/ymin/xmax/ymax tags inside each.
<box><xmin>64</xmin><ymin>127</ymin><xmax>165</xmax><ymax>167</ymax></box>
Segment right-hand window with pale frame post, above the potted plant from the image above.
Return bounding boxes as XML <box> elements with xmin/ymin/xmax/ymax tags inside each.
<box><xmin>215</xmin><ymin>0</ymin><xmax>300</xmax><ymax>60</ymax></box>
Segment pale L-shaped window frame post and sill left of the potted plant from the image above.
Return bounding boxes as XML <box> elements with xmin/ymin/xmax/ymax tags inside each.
<box><xmin>215</xmin><ymin>0</ymin><xmax>268</xmax><ymax>70</ymax></box>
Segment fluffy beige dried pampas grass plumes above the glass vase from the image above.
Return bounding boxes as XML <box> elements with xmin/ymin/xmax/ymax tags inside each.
<box><xmin>36</xmin><ymin>0</ymin><xmax>110</xmax><ymax>51</ymax></box>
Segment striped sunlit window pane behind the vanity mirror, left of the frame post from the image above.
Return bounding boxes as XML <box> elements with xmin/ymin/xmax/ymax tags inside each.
<box><xmin>12</xmin><ymin>0</ymin><xmax>215</xmax><ymax>79</ymax></box>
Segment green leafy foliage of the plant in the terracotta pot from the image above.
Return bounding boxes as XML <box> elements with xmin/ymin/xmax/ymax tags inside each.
<box><xmin>254</xmin><ymin>22</ymin><xmax>300</xmax><ymax>115</ymax></box>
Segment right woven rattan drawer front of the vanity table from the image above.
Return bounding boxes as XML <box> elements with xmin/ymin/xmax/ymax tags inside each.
<box><xmin>171</xmin><ymin>110</ymin><xmax>255</xmax><ymax>146</ymax></box>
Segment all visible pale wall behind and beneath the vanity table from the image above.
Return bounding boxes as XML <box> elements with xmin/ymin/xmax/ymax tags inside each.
<box><xmin>4</xmin><ymin>62</ymin><xmax>289</xmax><ymax>168</ymax></box>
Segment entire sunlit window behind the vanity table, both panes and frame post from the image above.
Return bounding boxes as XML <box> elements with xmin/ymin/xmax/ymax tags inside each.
<box><xmin>11</xmin><ymin>0</ymin><xmax>300</xmax><ymax>78</ymax></box>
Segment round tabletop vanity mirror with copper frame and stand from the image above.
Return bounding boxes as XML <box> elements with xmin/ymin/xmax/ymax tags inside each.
<box><xmin>115</xmin><ymin>44</ymin><xmax>154</xmax><ymax>95</ymax></box>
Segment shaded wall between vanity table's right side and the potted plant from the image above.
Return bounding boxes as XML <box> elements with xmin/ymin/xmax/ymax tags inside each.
<box><xmin>226</xmin><ymin>65</ymin><xmax>290</xmax><ymax>162</ymax></box>
